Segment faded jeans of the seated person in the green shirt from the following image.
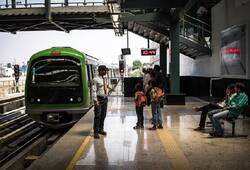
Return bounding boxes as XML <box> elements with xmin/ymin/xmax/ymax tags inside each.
<box><xmin>208</xmin><ymin>109</ymin><xmax>229</xmax><ymax>135</ymax></box>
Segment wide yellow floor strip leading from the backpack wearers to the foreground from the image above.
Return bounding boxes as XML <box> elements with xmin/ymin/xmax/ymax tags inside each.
<box><xmin>147</xmin><ymin>110</ymin><xmax>193</xmax><ymax>170</ymax></box>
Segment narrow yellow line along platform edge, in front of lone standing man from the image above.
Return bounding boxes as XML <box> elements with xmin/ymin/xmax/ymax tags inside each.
<box><xmin>66</xmin><ymin>136</ymin><xmax>91</xmax><ymax>170</ymax></box>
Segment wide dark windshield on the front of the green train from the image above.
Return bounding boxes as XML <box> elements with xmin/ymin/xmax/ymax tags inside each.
<box><xmin>29</xmin><ymin>58</ymin><xmax>81</xmax><ymax>87</ymax></box>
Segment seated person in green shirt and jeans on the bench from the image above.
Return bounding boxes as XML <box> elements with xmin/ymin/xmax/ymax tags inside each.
<box><xmin>208</xmin><ymin>82</ymin><xmax>248</xmax><ymax>136</ymax></box>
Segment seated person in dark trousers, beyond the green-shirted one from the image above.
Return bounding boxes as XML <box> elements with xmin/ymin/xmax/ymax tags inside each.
<box><xmin>194</xmin><ymin>84</ymin><xmax>236</xmax><ymax>131</ymax></box>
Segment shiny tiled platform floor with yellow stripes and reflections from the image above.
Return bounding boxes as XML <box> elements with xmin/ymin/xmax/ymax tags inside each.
<box><xmin>28</xmin><ymin>87</ymin><xmax>250</xmax><ymax>170</ymax></box>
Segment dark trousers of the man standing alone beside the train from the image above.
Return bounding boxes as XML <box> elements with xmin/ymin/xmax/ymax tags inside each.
<box><xmin>94</xmin><ymin>98</ymin><xmax>108</xmax><ymax>133</ymax></box>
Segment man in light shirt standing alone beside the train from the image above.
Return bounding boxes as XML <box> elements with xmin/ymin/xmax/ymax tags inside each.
<box><xmin>93</xmin><ymin>65</ymin><xmax>108</xmax><ymax>139</ymax></box>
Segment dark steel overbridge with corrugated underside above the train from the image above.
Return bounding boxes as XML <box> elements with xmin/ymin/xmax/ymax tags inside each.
<box><xmin>0</xmin><ymin>0</ymin><xmax>121</xmax><ymax>33</ymax></box>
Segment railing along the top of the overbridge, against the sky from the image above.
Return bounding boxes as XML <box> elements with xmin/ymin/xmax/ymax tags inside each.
<box><xmin>0</xmin><ymin>0</ymin><xmax>107</xmax><ymax>9</ymax></box>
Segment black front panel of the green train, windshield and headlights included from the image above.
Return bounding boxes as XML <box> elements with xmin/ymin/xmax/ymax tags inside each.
<box><xmin>27</xmin><ymin>57</ymin><xmax>83</xmax><ymax>104</ymax></box>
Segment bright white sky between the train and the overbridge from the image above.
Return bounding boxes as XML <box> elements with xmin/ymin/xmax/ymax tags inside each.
<box><xmin>0</xmin><ymin>29</ymin><xmax>149</xmax><ymax>66</ymax></box>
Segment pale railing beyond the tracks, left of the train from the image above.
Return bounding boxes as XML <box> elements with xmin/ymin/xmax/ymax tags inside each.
<box><xmin>0</xmin><ymin>78</ymin><xmax>25</xmax><ymax>96</ymax></box>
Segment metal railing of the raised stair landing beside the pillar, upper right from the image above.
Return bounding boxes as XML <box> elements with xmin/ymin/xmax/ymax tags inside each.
<box><xmin>180</xmin><ymin>14</ymin><xmax>211</xmax><ymax>48</ymax></box>
